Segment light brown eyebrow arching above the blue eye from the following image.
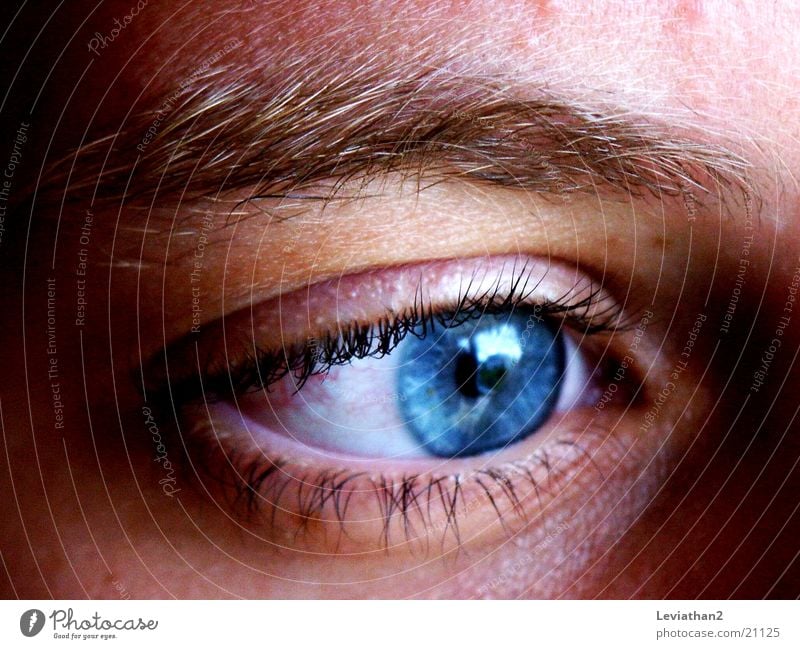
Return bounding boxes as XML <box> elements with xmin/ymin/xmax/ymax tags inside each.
<box><xmin>48</xmin><ymin>55</ymin><xmax>752</xmax><ymax>210</ymax></box>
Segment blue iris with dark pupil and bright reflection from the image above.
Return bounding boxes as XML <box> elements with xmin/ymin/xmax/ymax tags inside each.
<box><xmin>397</xmin><ymin>311</ymin><xmax>565</xmax><ymax>457</ymax></box>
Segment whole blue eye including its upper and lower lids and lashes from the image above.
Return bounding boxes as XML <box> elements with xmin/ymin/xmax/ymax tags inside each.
<box><xmin>144</xmin><ymin>255</ymin><xmax>644</xmax><ymax>552</ymax></box>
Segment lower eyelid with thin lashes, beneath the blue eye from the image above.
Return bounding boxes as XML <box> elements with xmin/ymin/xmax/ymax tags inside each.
<box><xmin>181</xmin><ymin>402</ymin><xmax>622</xmax><ymax>556</ymax></box>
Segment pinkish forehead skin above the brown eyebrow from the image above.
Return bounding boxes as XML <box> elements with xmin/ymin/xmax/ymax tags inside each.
<box><xmin>7</xmin><ymin>0</ymin><xmax>800</xmax><ymax>235</ymax></box>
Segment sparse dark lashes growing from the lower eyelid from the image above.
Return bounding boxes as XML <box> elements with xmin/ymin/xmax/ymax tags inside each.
<box><xmin>219</xmin><ymin>438</ymin><xmax>591</xmax><ymax>550</ymax></box>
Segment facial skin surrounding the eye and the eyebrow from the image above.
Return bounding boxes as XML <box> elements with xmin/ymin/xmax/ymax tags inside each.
<box><xmin>0</xmin><ymin>1</ymin><xmax>800</xmax><ymax>598</ymax></box>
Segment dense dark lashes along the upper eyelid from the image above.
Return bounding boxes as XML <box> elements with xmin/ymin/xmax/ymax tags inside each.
<box><xmin>195</xmin><ymin>267</ymin><xmax>621</xmax><ymax>401</ymax></box>
